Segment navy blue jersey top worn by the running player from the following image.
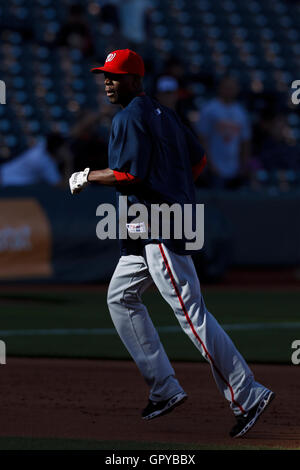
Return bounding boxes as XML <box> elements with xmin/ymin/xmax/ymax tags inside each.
<box><xmin>108</xmin><ymin>95</ymin><xmax>205</xmax><ymax>255</ymax></box>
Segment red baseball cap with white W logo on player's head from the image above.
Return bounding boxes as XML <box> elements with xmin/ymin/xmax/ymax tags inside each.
<box><xmin>91</xmin><ymin>49</ymin><xmax>145</xmax><ymax>77</ymax></box>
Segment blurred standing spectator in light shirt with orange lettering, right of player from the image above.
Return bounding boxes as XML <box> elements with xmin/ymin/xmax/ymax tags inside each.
<box><xmin>196</xmin><ymin>76</ymin><xmax>251</xmax><ymax>188</ymax></box>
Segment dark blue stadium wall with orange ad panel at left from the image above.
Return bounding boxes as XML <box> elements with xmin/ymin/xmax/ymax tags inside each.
<box><xmin>0</xmin><ymin>186</ymin><xmax>300</xmax><ymax>283</ymax></box>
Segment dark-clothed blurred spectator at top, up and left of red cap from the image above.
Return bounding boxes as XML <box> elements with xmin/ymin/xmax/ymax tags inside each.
<box><xmin>55</xmin><ymin>3</ymin><xmax>94</xmax><ymax>56</ymax></box>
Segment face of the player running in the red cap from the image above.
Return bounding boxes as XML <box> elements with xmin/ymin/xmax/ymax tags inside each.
<box><xmin>104</xmin><ymin>72</ymin><xmax>136</xmax><ymax>106</ymax></box>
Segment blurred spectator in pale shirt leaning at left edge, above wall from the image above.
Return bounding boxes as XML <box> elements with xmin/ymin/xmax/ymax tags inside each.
<box><xmin>0</xmin><ymin>134</ymin><xmax>65</xmax><ymax>186</ymax></box>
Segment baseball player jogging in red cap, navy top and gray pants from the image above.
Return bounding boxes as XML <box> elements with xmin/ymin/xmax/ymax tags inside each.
<box><xmin>69</xmin><ymin>49</ymin><xmax>274</xmax><ymax>437</ymax></box>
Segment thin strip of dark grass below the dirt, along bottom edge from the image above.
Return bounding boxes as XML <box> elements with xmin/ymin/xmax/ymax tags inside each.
<box><xmin>0</xmin><ymin>437</ymin><xmax>294</xmax><ymax>451</ymax></box>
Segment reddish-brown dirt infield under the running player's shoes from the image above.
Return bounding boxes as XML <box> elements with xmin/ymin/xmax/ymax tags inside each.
<box><xmin>0</xmin><ymin>358</ymin><xmax>300</xmax><ymax>448</ymax></box>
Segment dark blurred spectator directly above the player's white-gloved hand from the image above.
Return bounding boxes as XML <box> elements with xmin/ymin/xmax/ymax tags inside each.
<box><xmin>70</xmin><ymin>111</ymin><xmax>108</xmax><ymax>172</ymax></box>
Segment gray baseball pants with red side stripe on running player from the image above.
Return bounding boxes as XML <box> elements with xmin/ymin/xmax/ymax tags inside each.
<box><xmin>107</xmin><ymin>244</ymin><xmax>267</xmax><ymax>415</ymax></box>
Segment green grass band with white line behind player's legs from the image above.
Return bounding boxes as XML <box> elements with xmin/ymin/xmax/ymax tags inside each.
<box><xmin>0</xmin><ymin>289</ymin><xmax>300</xmax><ymax>364</ymax></box>
